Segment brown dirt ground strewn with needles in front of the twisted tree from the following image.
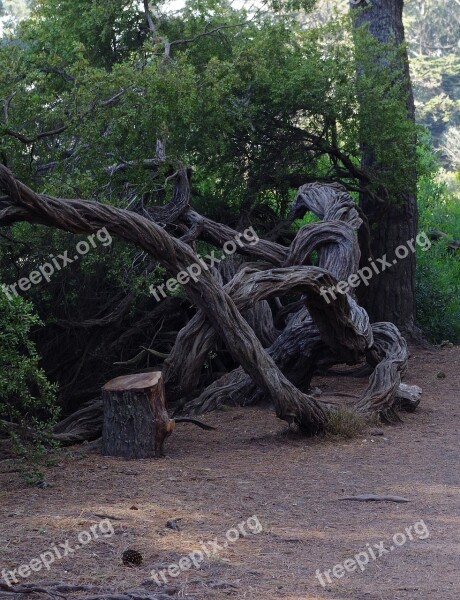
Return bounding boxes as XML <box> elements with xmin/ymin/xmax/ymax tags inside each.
<box><xmin>0</xmin><ymin>347</ymin><xmax>460</xmax><ymax>600</ymax></box>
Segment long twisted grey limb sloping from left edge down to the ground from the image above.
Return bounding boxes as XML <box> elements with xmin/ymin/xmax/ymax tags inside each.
<box><xmin>0</xmin><ymin>165</ymin><xmax>330</xmax><ymax>434</ymax></box>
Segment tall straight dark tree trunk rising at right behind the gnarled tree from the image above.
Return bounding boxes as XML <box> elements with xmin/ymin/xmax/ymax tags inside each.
<box><xmin>350</xmin><ymin>0</ymin><xmax>417</xmax><ymax>335</ymax></box>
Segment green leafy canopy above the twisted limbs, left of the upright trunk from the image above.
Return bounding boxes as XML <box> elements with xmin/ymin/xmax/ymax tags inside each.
<box><xmin>0</xmin><ymin>0</ymin><xmax>359</xmax><ymax>209</ymax></box>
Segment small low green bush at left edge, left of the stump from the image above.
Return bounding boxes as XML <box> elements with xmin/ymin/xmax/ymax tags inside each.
<box><xmin>0</xmin><ymin>292</ymin><xmax>59</xmax><ymax>479</ymax></box>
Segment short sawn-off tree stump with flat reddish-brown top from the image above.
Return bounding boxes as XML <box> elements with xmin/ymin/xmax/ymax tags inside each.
<box><xmin>102</xmin><ymin>371</ymin><xmax>174</xmax><ymax>458</ymax></box>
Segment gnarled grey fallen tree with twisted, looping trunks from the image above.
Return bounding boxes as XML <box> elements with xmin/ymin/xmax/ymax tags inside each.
<box><xmin>0</xmin><ymin>166</ymin><xmax>420</xmax><ymax>442</ymax></box>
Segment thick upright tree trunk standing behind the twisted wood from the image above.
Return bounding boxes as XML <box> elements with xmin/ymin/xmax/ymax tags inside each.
<box><xmin>350</xmin><ymin>0</ymin><xmax>418</xmax><ymax>336</ymax></box>
